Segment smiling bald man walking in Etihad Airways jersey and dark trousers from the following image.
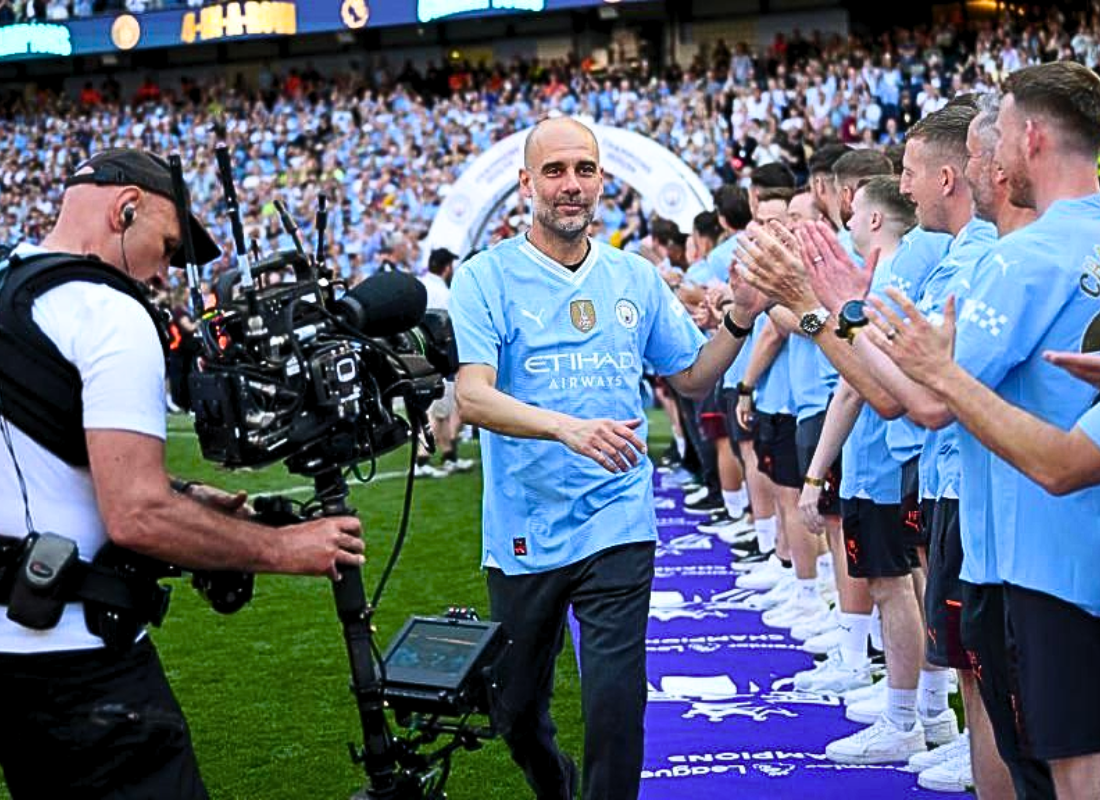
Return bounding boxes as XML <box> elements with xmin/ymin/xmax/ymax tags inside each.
<box><xmin>451</xmin><ymin>118</ymin><xmax>763</xmax><ymax>800</ymax></box>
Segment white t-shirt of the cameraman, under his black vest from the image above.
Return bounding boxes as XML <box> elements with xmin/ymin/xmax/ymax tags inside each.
<box><xmin>0</xmin><ymin>244</ymin><xmax>167</xmax><ymax>653</ymax></box>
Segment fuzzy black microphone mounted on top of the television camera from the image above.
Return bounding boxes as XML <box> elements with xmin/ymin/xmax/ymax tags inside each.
<box><xmin>332</xmin><ymin>272</ymin><xmax>428</xmax><ymax>337</ymax></box>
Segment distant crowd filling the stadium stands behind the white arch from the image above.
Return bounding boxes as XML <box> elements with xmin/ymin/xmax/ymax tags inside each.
<box><xmin>0</xmin><ymin>0</ymin><xmax>1100</xmax><ymax>299</ymax></box>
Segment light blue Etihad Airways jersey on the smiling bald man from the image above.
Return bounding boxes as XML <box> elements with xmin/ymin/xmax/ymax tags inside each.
<box><xmin>451</xmin><ymin>235</ymin><xmax>706</xmax><ymax>574</ymax></box>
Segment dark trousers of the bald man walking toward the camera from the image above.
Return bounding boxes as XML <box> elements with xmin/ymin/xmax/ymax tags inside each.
<box><xmin>488</xmin><ymin>543</ymin><xmax>653</xmax><ymax>800</ymax></box>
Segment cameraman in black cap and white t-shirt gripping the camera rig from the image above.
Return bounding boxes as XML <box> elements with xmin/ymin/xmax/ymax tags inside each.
<box><xmin>0</xmin><ymin>150</ymin><xmax>363</xmax><ymax>800</ymax></box>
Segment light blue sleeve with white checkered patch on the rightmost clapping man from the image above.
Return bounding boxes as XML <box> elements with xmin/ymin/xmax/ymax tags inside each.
<box><xmin>955</xmin><ymin>246</ymin><xmax>1066</xmax><ymax>387</ymax></box>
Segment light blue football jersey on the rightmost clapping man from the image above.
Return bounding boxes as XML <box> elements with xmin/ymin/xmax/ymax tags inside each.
<box><xmin>955</xmin><ymin>195</ymin><xmax>1100</xmax><ymax>615</ymax></box>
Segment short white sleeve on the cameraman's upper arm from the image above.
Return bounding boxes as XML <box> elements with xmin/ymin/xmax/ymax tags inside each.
<box><xmin>32</xmin><ymin>282</ymin><xmax>167</xmax><ymax>440</ymax></box>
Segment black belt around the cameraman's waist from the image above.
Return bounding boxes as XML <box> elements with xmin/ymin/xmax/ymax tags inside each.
<box><xmin>0</xmin><ymin>536</ymin><xmax>171</xmax><ymax>625</ymax></box>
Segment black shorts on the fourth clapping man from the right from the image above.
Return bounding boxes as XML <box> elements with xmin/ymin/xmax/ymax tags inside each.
<box><xmin>840</xmin><ymin>497</ymin><xmax>915</xmax><ymax>578</ymax></box>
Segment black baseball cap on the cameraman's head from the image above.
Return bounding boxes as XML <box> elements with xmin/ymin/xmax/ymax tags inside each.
<box><xmin>65</xmin><ymin>147</ymin><xmax>221</xmax><ymax>266</ymax></box>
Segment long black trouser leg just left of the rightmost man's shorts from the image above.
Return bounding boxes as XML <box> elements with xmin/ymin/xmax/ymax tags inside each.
<box><xmin>959</xmin><ymin>581</ymin><xmax>1056</xmax><ymax>800</ymax></box>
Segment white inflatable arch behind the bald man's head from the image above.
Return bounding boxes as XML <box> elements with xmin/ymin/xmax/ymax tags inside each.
<box><xmin>428</xmin><ymin>124</ymin><xmax>714</xmax><ymax>257</ymax></box>
